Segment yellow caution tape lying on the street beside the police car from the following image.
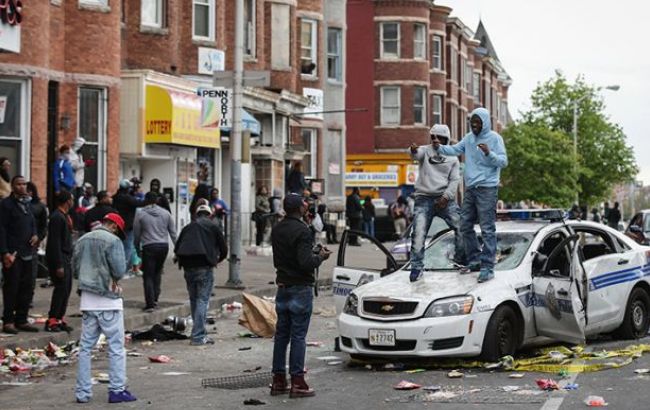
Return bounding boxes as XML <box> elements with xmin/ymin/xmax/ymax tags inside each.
<box><xmin>351</xmin><ymin>344</ymin><xmax>650</xmax><ymax>373</ymax></box>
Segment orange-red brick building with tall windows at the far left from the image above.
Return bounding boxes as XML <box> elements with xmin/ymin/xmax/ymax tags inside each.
<box><xmin>0</xmin><ymin>0</ymin><xmax>120</xmax><ymax>203</ymax></box>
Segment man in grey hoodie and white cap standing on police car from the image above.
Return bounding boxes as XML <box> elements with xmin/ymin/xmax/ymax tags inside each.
<box><xmin>409</xmin><ymin>124</ymin><xmax>465</xmax><ymax>282</ymax></box>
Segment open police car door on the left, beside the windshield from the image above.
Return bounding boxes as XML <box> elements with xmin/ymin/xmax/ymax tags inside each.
<box><xmin>332</xmin><ymin>230</ymin><xmax>398</xmax><ymax>313</ymax></box>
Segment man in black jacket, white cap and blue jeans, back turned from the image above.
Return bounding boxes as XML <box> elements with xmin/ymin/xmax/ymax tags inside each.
<box><xmin>174</xmin><ymin>205</ymin><xmax>228</xmax><ymax>346</ymax></box>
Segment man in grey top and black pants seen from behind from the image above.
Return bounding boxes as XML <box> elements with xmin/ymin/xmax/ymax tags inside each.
<box><xmin>133</xmin><ymin>192</ymin><xmax>176</xmax><ymax>312</ymax></box>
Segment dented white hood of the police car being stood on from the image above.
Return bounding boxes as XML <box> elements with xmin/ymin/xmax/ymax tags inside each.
<box><xmin>354</xmin><ymin>270</ymin><xmax>478</xmax><ymax>302</ymax></box>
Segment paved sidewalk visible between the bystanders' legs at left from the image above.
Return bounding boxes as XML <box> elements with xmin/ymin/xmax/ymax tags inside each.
<box><xmin>0</xmin><ymin>245</ymin><xmax>350</xmax><ymax>349</ymax></box>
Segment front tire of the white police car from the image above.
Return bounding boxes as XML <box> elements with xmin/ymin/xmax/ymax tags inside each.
<box><xmin>481</xmin><ymin>306</ymin><xmax>519</xmax><ymax>362</ymax></box>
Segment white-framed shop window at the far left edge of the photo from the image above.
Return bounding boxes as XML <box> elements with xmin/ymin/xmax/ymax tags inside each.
<box><xmin>0</xmin><ymin>79</ymin><xmax>28</xmax><ymax>177</ymax></box>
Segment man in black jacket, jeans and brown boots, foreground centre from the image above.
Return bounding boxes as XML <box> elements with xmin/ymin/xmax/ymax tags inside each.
<box><xmin>271</xmin><ymin>194</ymin><xmax>330</xmax><ymax>398</ymax></box>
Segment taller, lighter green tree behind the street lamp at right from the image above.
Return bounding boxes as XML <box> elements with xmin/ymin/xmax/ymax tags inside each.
<box><xmin>520</xmin><ymin>71</ymin><xmax>638</xmax><ymax>204</ymax></box>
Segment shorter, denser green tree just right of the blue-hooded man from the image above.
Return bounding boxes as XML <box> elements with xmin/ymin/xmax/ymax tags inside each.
<box><xmin>499</xmin><ymin>122</ymin><xmax>576</xmax><ymax>207</ymax></box>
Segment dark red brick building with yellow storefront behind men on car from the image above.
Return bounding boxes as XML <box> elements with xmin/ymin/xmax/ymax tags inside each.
<box><xmin>346</xmin><ymin>0</ymin><xmax>511</xmax><ymax>202</ymax></box>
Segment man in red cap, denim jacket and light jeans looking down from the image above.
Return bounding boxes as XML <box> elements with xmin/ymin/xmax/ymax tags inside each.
<box><xmin>72</xmin><ymin>213</ymin><xmax>136</xmax><ymax>403</ymax></box>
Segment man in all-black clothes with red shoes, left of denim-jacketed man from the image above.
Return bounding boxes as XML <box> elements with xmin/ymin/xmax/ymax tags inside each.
<box><xmin>45</xmin><ymin>191</ymin><xmax>74</xmax><ymax>332</ymax></box>
